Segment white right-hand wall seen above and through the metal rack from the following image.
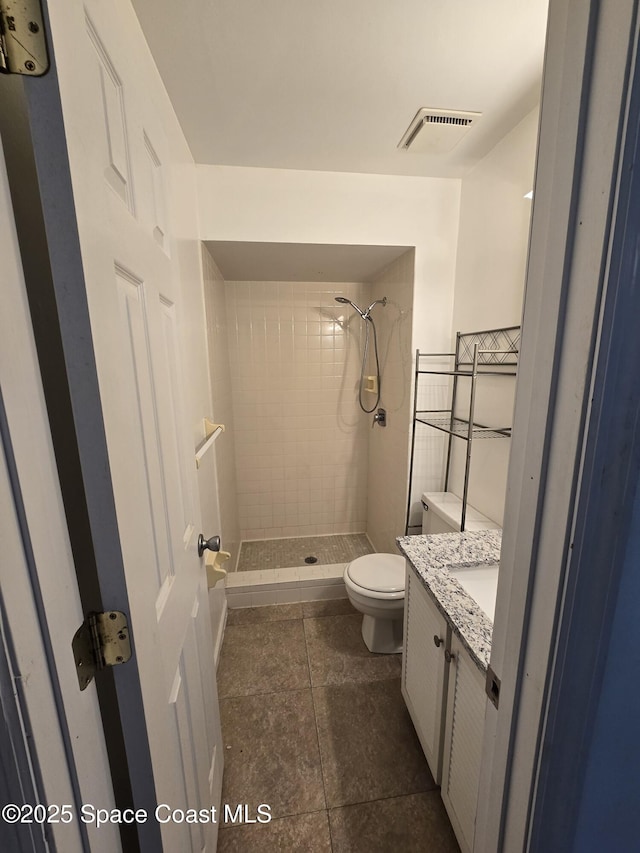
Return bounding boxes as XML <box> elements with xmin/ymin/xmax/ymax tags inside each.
<box><xmin>449</xmin><ymin>103</ymin><xmax>538</xmax><ymax>524</ymax></box>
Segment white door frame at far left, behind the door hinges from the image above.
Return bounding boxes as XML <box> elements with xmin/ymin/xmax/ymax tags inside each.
<box><xmin>0</xmin><ymin>133</ymin><xmax>120</xmax><ymax>853</ymax></box>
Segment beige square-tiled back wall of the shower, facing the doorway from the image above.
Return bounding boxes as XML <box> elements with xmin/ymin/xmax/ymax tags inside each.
<box><xmin>225</xmin><ymin>282</ymin><xmax>371</xmax><ymax>539</ymax></box>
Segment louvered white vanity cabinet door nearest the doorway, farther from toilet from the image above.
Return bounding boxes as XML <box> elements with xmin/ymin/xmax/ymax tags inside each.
<box><xmin>441</xmin><ymin>636</ymin><xmax>487</xmax><ymax>853</ymax></box>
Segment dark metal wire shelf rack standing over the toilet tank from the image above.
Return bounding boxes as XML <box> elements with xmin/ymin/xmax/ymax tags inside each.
<box><xmin>405</xmin><ymin>326</ymin><xmax>520</xmax><ymax>535</ymax></box>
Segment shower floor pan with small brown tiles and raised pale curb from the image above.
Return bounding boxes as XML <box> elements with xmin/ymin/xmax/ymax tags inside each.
<box><xmin>226</xmin><ymin>533</ymin><xmax>374</xmax><ymax>608</ymax></box>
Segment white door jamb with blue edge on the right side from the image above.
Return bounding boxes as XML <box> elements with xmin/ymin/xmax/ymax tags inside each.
<box><xmin>475</xmin><ymin>0</ymin><xmax>638</xmax><ymax>853</ymax></box>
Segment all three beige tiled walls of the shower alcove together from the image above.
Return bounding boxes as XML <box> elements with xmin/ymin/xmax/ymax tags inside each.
<box><xmin>203</xmin><ymin>248</ymin><xmax>413</xmax><ymax>572</ymax></box>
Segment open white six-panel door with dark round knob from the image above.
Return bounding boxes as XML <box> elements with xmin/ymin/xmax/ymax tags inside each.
<box><xmin>38</xmin><ymin>0</ymin><xmax>222</xmax><ymax>851</ymax></box>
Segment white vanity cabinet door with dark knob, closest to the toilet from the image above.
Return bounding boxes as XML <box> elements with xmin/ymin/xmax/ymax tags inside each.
<box><xmin>402</xmin><ymin>567</ymin><xmax>448</xmax><ymax>784</ymax></box>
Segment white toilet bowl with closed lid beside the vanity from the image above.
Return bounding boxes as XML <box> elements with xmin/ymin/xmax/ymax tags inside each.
<box><xmin>344</xmin><ymin>554</ymin><xmax>405</xmax><ymax>654</ymax></box>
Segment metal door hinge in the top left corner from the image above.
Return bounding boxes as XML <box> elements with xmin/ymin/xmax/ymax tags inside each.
<box><xmin>0</xmin><ymin>0</ymin><xmax>49</xmax><ymax>77</ymax></box>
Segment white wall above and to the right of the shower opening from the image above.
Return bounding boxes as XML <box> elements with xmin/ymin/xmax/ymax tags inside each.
<box><xmin>196</xmin><ymin>165</ymin><xmax>460</xmax><ymax>349</ymax></box>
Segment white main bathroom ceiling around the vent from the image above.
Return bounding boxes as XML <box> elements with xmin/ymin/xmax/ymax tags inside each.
<box><xmin>133</xmin><ymin>0</ymin><xmax>547</xmax><ymax>177</ymax></box>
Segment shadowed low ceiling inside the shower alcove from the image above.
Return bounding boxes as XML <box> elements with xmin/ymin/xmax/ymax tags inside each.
<box><xmin>205</xmin><ymin>240</ymin><xmax>409</xmax><ymax>282</ymax></box>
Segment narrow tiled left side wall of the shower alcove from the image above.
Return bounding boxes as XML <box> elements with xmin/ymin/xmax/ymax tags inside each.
<box><xmin>202</xmin><ymin>247</ymin><xmax>240</xmax><ymax>568</ymax></box>
